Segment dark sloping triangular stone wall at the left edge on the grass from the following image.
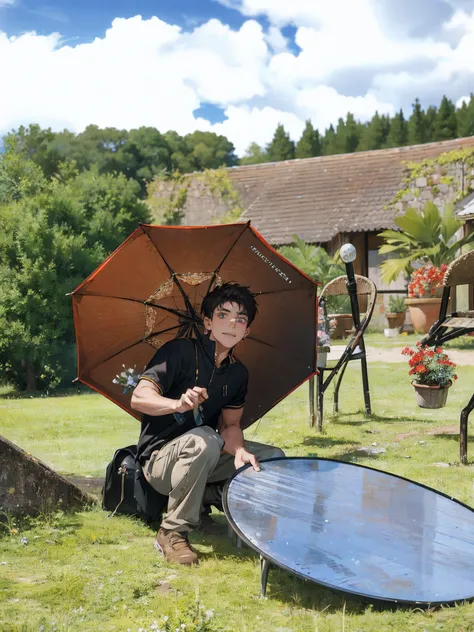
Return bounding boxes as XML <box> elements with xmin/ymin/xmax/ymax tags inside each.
<box><xmin>0</xmin><ymin>436</ymin><xmax>94</xmax><ymax>515</ymax></box>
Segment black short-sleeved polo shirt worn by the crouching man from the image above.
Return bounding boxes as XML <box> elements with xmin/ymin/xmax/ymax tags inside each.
<box><xmin>138</xmin><ymin>335</ymin><xmax>248</xmax><ymax>463</ymax></box>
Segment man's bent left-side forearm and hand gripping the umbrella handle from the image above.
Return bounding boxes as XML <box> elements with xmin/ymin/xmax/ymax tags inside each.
<box><xmin>130</xmin><ymin>380</ymin><xmax>208</xmax><ymax>417</ymax></box>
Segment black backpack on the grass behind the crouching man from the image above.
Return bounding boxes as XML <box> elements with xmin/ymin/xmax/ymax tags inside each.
<box><xmin>102</xmin><ymin>445</ymin><xmax>168</xmax><ymax>523</ymax></box>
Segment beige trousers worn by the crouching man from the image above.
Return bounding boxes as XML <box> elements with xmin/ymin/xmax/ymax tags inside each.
<box><xmin>143</xmin><ymin>426</ymin><xmax>285</xmax><ymax>531</ymax></box>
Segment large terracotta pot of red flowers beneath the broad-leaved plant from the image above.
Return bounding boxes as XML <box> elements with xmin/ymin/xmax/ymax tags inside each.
<box><xmin>406</xmin><ymin>264</ymin><xmax>448</xmax><ymax>334</ymax></box>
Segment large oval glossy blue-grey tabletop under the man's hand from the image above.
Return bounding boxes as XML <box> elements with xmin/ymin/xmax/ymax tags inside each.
<box><xmin>224</xmin><ymin>458</ymin><xmax>474</xmax><ymax>604</ymax></box>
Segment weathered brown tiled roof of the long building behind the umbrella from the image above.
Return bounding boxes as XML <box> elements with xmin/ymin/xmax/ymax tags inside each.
<box><xmin>224</xmin><ymin>137</ymin><xmax>474</xmax><ymax>244</ymax></box>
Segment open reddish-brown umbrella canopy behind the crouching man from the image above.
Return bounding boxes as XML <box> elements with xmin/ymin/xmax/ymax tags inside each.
<box><xmin>72</xmin><ymin>223</ymin><xmax>317</xmax><ymax>428</ymax></box>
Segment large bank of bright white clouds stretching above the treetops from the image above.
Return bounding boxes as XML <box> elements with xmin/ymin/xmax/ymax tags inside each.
<box><xmin>0</xmin><ymin>0</ymin><xmax>474</xmax><ymax>154</ymax></box>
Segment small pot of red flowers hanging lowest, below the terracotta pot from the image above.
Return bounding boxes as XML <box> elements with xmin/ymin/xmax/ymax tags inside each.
<box><xmin>402</xmin><ymin>342</ymin><xmax>458</xmax><ymax>408</ymax></box>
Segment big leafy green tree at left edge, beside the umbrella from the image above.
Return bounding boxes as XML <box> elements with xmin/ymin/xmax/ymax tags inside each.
<box><xmin>0</xmin><ymin>160</ymin><xmax>149</xmax><ymax>389</ymax></box>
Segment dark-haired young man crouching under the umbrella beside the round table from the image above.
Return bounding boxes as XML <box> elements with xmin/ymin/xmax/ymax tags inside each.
<box><xmin>131</xmin><ymin>283</ymin><xmax>284</xmax><ymax>564</ymax></box>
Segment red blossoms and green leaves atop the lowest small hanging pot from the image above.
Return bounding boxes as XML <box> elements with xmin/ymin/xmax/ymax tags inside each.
<box><xmin>402</xmin><ymin>342</ymin><xmax>458</xmax><ymax>388</ymax></box>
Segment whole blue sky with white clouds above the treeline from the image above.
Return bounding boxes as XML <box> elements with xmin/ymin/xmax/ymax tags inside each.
<box><xmin>0</xmin><ymin>0</ymin><xmax>474</xmax><ymax>156</ymax></box>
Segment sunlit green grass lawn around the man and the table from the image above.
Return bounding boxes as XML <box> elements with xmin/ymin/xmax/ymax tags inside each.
<box><xmin>0</xmin><ymin>360</ymin><xmax>474</xmax><ymax>632</ymax></box>
